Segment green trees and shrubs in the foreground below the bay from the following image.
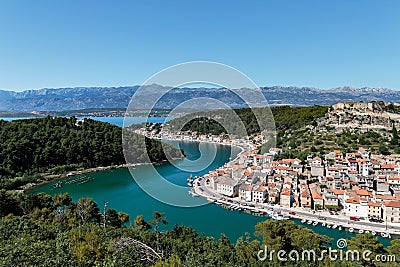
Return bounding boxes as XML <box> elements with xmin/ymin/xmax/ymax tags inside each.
<box><xmin>0</xmin><ymin>190</ymin><xmax>394</xmax><ymax>267</ymax></box>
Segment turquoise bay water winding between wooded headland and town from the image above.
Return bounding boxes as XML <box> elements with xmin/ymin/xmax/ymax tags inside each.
<box><xmin>25</xmin><ymin>117</ymin><xmax>390</xmax><ymax>247</ymax></box>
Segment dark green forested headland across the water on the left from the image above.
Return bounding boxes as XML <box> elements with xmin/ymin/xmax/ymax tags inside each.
<box><xmin>0</xmin><ymin>117</ymin><xmax>180</xmax><ymax>189</ymax></box>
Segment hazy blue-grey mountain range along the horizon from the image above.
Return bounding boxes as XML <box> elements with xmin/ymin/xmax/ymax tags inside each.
<box><xmin>0</xmin><ymin>85</ymin><xmax>400</xmax><ymax>112</ymax></box>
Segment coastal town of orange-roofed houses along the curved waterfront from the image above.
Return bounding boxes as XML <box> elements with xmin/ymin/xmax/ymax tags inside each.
<box><xmin>135</xmin><ymin>119</ymin><xmax>400</xmax><ymax>238</ymax></box>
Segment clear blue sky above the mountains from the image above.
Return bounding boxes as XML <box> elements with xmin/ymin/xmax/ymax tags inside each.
<box><xmin>0</xmin><ymin>0</ymin><xmax>400</xmax><ymax>90</ymax></box>
